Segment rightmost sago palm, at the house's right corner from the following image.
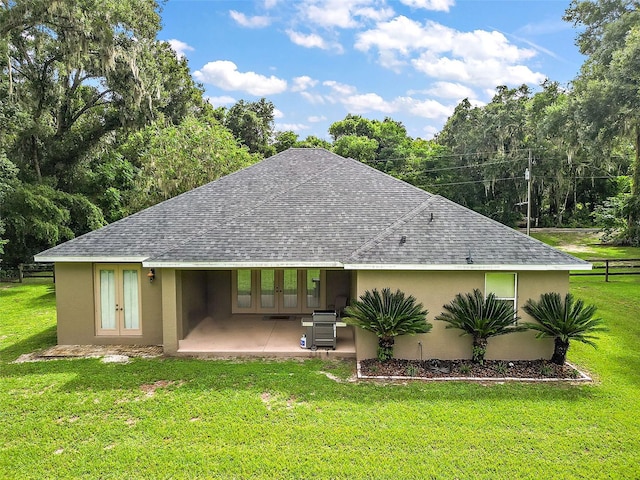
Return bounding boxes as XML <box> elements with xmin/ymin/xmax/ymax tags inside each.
<box><xmin>523</xmin><ymin>292</ymin><xmax>606</xmax><ymax>365</ymax></box>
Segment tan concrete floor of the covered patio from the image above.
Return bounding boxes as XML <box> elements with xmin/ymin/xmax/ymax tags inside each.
<box><xmin>178</xmin><ymin>315</ymin><xmax>356</xmax><ymax>358</ymax></box>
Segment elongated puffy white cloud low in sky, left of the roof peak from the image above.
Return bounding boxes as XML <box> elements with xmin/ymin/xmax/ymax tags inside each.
<box><xmin>193</xmin><ymin>60</ymin><xmax>287</xmax><ymax>96</ymax></box>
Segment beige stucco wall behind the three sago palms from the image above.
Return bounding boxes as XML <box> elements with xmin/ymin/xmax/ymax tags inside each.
<box><xmin>352</xmin><ymin>271</ymin><xmax>569</xmax><ymax>360</ymax></box>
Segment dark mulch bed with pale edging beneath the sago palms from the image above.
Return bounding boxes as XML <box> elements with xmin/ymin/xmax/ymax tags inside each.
<box><xmin>359</xmin><ymin>358</ymin><xmax>588</xmax><ymax>380</ymax></box>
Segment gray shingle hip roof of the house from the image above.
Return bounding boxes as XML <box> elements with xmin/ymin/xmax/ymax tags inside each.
<box><xmin>36</xmin><ymin>149</ymin><xmax>587</xmax><ymax>268</ymax></box>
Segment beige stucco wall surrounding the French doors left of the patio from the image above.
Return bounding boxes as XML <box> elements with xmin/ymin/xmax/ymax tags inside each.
<box><xmin>55</xmin><ymin>263</ymin><xmax>162</xmax><ymax>345</ymax></box>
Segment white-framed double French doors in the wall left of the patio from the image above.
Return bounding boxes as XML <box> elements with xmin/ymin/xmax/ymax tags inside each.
<box><xmin>94</xmin><ymin>264</ymin><xmax>142</xmax><ymax>335</ymax></box>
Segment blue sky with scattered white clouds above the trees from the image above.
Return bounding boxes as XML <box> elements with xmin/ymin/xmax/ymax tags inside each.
<box><xmin>159</xmin><ymin>0</ymin><xmax>584</xmax><ymax>139</ymax></box>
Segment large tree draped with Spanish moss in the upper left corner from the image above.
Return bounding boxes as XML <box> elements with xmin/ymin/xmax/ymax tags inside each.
<box><xmin>0</xmin><ymin>0</ymin><xmax>168</xmax><ymax>181</ymax></box>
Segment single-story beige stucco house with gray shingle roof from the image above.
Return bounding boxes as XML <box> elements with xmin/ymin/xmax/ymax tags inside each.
<box><xmin>35</xmin><ymin>148</ymin><xmax>591</xmax><ymax>360</ymax></box>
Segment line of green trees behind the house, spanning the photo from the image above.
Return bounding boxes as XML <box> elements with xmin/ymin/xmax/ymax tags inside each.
<box><xmin>0</xmin><ymin>0</ymin><xmax>640</xmax><ymax>268</ymax></box>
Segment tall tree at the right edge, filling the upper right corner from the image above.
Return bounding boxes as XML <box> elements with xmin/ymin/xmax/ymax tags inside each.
<box><xmin>564</xmin><ymin>0</ymin><xmax>640</xmax><ymax>244</ymax></box>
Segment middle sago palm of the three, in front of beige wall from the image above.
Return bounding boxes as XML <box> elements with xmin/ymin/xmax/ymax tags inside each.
<box><xmin>436</xmin><ymin>289</ymin><xmax>526</xmax><ymax>364</ymax></box>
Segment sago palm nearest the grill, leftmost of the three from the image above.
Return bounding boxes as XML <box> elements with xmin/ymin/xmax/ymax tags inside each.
<box><xmin>344</xmin><ymin>288</ymin><xmax>433</xmax><ymax>361</ymax></box>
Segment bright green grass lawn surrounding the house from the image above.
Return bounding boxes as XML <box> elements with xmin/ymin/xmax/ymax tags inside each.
<box><xmin>0</xmin><ymin>276</ymin><xmax>640</xmax><ymax>479</ymax></box>
